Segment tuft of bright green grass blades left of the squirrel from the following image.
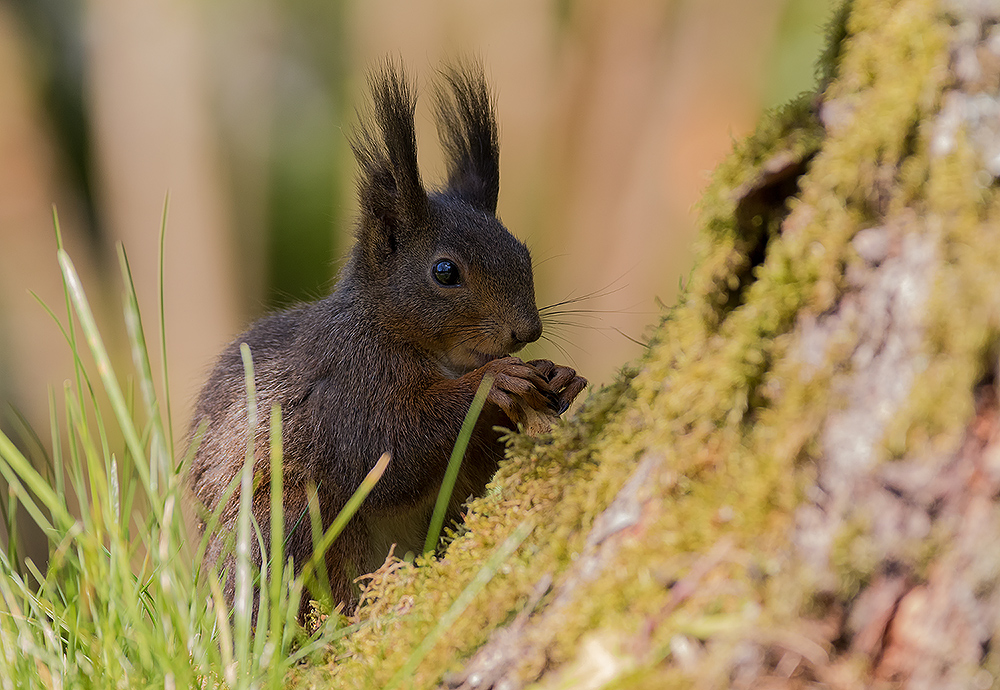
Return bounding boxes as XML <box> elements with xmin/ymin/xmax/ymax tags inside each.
<box><xmin>0</xmin><ymin>230</ymin><xmax>372</xmax><ymax>689</ymax></box>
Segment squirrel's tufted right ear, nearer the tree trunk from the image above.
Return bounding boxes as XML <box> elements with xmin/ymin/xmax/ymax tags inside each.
<box><xmin>437</xmin><ymin>62</ymin><xmax>500</xmax><ymax>214</ymax></box>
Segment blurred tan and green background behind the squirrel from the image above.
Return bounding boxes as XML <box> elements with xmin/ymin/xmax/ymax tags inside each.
<box><xmin>0</xmin><ymin>0</ymin><xmax>833</xmax><ymax>460</ymax></box>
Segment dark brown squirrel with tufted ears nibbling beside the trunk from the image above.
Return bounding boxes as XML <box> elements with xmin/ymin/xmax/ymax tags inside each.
<box><xmin>188</xmin><ymin>63</ymin><xmax>587</xmax><ymax>604</ymax></box>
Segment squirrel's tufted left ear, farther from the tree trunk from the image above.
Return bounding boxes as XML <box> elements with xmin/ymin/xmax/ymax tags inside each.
<box><xmin>351</xmin><ymin>62</ymin><xmax>427</xmax><ymax>250</ymax></box>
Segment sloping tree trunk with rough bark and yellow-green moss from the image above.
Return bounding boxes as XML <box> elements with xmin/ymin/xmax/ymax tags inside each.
<box><xmin>314</xmin><ymin>0</ymin><xmax>1000</xmax><ymax>688</ymax></box>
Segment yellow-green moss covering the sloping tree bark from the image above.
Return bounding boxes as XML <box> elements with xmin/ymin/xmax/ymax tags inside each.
<box><xmin>300</xmin><ymin>0</ymin><xmax>1000</xmax><ymax>688</ymax></box>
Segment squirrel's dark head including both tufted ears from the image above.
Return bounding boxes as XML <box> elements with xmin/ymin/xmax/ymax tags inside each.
<box><xmin>351</xmin><ymin>63</ymin><xmax>542</xmax><ymax>376</ymax></box>
